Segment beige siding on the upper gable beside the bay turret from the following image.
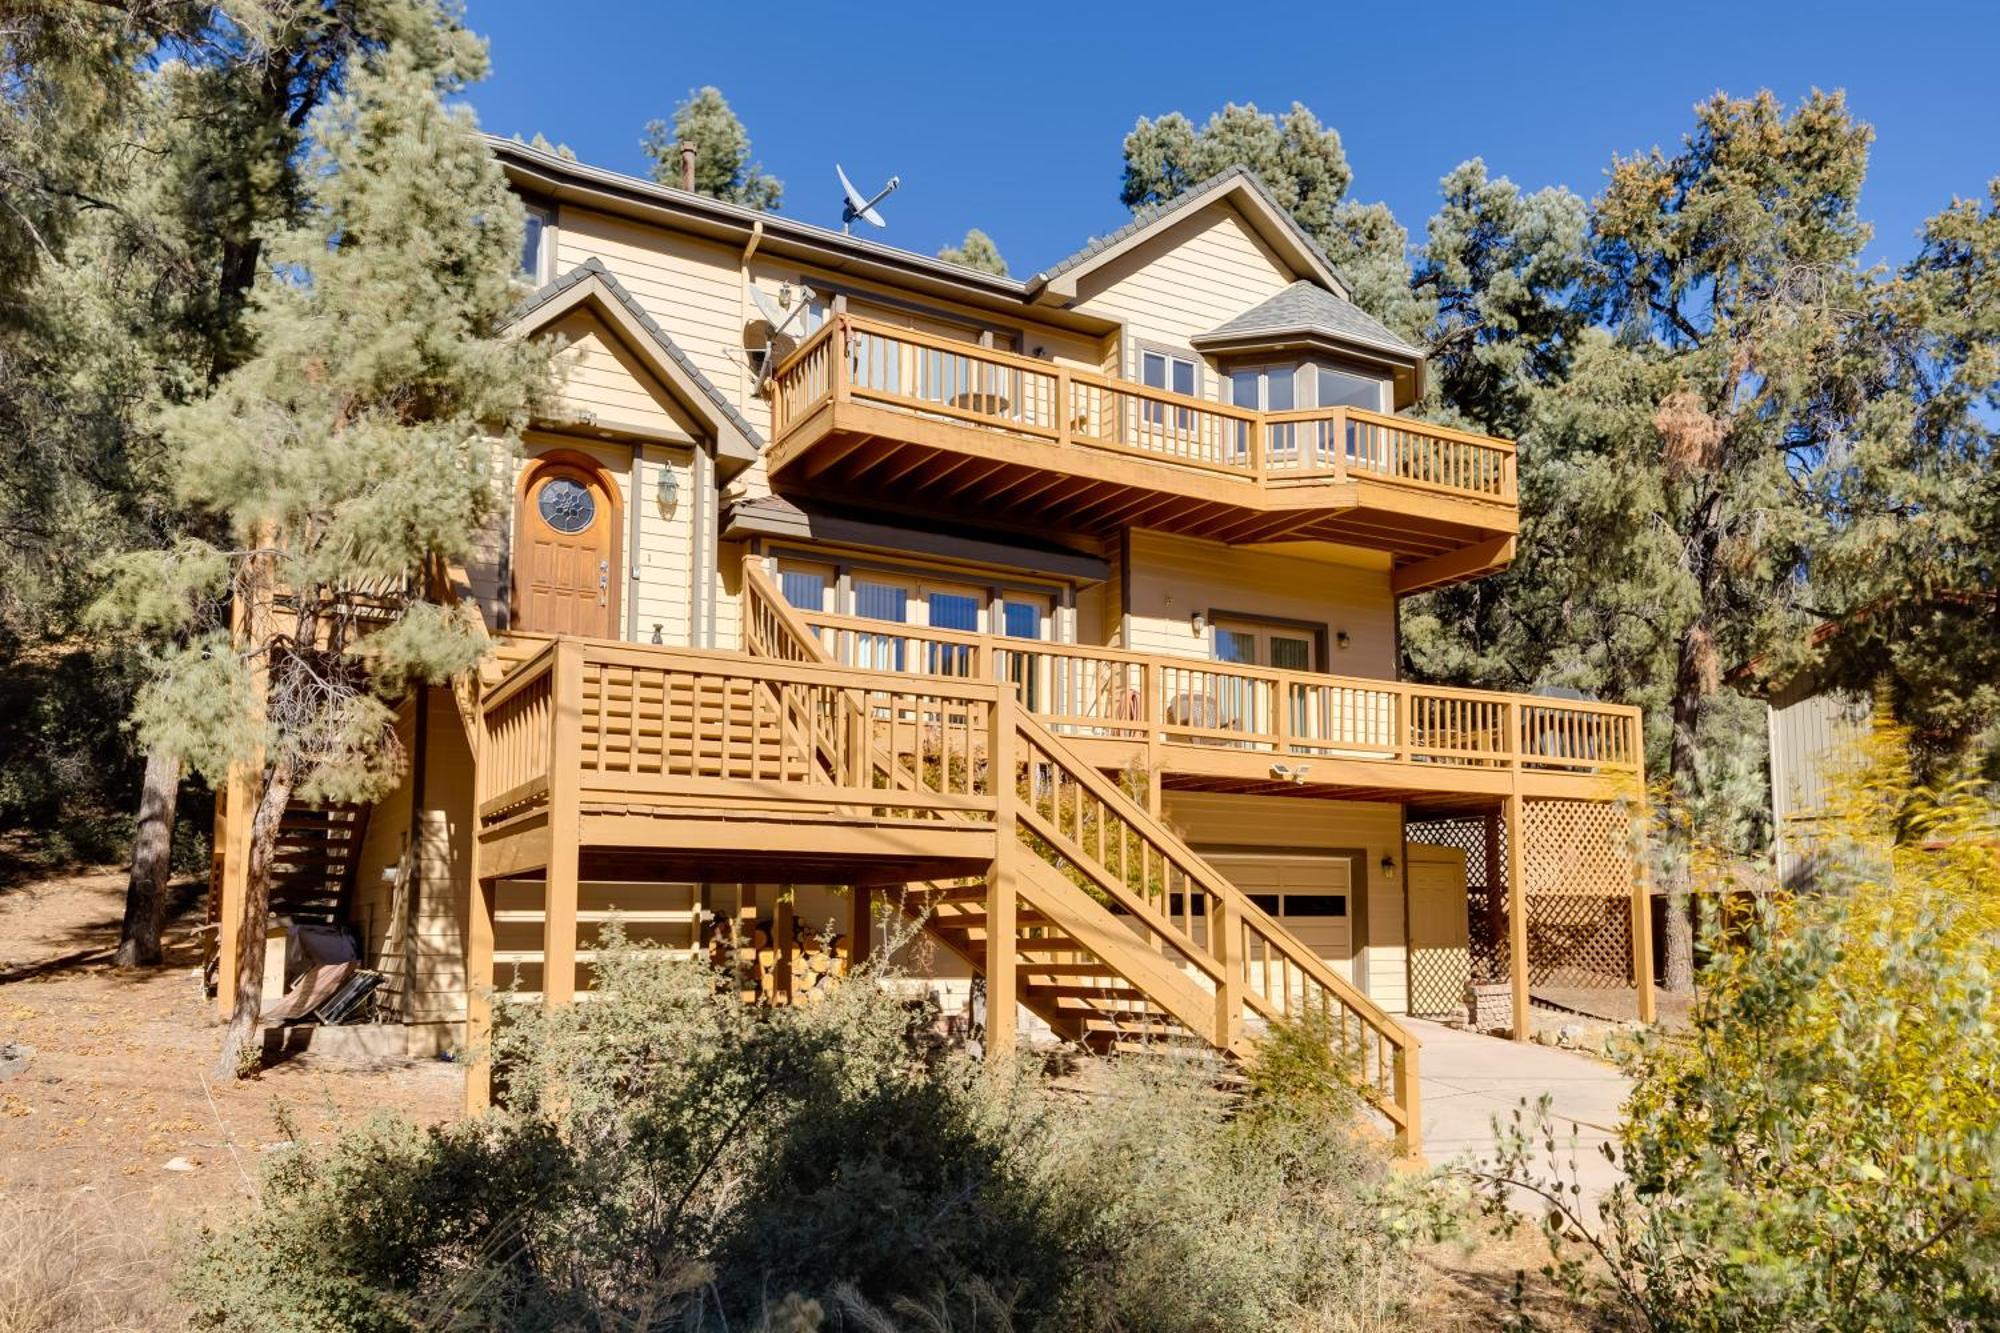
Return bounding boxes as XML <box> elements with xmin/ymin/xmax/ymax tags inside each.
<box><xmin>1074</xmin><ymin>202</ymin><xmax>1296</xmax><ymax>382</ymax></box>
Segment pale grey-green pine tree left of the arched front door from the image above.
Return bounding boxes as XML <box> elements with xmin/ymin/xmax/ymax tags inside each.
<box><xmin>98</xmin><ymin>32</ymin><xmax>548</xmax><ymax>1073</ymax></box>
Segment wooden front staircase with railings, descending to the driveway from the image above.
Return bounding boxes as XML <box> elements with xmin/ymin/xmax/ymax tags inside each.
<box><xmin>742</xmin><ymin>558</ymin><xmax>1420</xmax><ymax>1153</ymax></box>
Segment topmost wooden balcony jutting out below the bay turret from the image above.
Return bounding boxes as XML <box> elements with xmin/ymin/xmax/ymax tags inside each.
<box><xmin>768</xmin><ymin>318</ymin><xmax>1520</xmax><ymax>592</ymax></box>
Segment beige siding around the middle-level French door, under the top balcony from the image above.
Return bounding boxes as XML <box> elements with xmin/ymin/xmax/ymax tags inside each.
<box><xmin>1112</xmin><ymin>532</ymin><xmax>1396</xmax><ymax>681</ymax></box>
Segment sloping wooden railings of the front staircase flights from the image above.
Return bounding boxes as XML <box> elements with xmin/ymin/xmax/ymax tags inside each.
<box><xmin>742</xmin><ymin>558</ymin><xmax>1422</xmax><ymax>1151</ymax></box>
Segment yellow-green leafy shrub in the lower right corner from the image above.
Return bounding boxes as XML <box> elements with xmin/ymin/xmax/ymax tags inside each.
<box><xmin>1480</xmin><ymin>740</ymin><xmax>2000</xmax><ymax>1329</ymax></box>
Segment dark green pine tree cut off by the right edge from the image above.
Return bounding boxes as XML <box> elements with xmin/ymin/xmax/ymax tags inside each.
<box><xmin>1810</xmin><ymin>180</ymin><xmax>2000</xmax><ymax>783</ymax></box>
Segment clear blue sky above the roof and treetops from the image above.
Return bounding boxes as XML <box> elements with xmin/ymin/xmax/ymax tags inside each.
<box><xmin>468</xmin><ymin>0</ymin><xmax>2000</xmax><ymax>274</ymax></box>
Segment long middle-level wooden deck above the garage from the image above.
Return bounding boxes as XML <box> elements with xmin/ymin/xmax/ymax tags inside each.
<box><xmin>784</xmin><ymin>612</ymin><xmax>1644</xmax><ymax>809</ymax></box>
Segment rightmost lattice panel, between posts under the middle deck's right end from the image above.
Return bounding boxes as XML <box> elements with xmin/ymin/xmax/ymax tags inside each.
<box><xmin>1522</xmin><ymin>801</ymin><xmax>1636</xmax><ymax>989</ymax></box>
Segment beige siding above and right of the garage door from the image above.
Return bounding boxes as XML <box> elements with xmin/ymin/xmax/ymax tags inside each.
<box><xmin>1166</xmin><ymin>793</ymin><xmax>1410</xmax><ymax>1013</ymax></box>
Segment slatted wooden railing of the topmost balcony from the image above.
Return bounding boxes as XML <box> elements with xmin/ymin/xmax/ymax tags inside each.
<box><xmin>772</xmin><ymin>316</ymin><xmax>1516</xmax><ymax>504</ymax></box>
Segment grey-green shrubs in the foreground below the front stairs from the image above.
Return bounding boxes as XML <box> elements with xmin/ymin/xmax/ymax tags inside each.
<box><xmin>182</xmin><ymin>931</ymin><xmax>1424</xmax><ymax>1333</ymax></box>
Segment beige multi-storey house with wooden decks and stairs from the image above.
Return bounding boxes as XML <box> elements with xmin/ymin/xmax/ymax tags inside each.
<box><xmin>218</xmin><ymin>140</ymin><xmax>1652</xmax><ymax>1137</ymax></box>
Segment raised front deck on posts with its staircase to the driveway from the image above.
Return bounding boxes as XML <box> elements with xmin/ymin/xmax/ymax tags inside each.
<box><xmin>468</xmin><ymin>566</ymin><xmax>1420</xmax><ymax>1151</ymax></box>
